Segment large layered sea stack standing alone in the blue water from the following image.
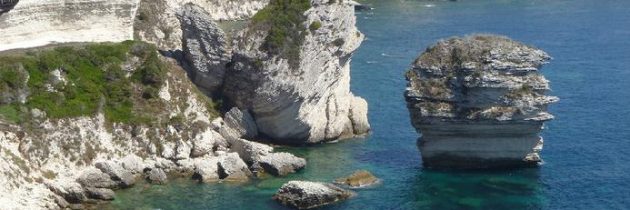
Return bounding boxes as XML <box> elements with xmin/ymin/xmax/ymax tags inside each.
<box><xmin>405</xmin><ymin>35</ymin><xmax>558</xmax><ymax>168</ymax></box>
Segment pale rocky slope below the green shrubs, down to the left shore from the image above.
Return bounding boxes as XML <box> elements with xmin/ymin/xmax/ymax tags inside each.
<box><xmin>0</xmin><ymin>53</ymin><xmax>304</xmax><ymax>209</ymax></box>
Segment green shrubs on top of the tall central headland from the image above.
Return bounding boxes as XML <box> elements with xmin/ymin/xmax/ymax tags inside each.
<box><xmin>252</xmin><ymin>0</ymin><xmax>312</xmax><ymax>68</ymax></box>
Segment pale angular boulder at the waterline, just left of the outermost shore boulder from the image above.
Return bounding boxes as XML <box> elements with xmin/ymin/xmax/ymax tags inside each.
<box><xmin>219</xmin><ymin>153</ymin><xmax>253</xmax><ymax>182</ymax></box>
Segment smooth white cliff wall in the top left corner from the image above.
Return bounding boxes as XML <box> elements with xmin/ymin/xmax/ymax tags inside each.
<box><xmin>0</xmin><ymin>0</ymin><xmax>140</xmax><ymax>51</ymax></box>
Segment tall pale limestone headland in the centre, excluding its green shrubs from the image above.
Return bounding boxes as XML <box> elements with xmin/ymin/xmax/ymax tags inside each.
<box><xmin>223</xmin><ymin>0</ymin><xmax>369</xmax><ymax>144</ymax></box>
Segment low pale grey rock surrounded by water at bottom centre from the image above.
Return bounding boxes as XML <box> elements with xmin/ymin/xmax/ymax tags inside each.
<box><xmin>273</xmin><ymin>181</ymin><xmax>354</xmax><ymax>209</ymax></box>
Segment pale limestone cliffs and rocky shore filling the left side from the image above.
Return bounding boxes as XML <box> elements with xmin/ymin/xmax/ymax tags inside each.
<box><xmin>0</xmin><ymin>0</ymin><xmax>370</xmax><ymax>209</ymax></box>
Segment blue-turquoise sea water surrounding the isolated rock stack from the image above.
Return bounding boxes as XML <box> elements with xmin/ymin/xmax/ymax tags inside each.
<box><xmin>105</xmin><ymin>0</ymin><xmax>630</xmax><ymax>210</ymax></box>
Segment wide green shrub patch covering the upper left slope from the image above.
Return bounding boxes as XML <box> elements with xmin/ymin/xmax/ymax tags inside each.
<box><xmin>0</xmin><ymin>41</ymin><xmax>167</xmax><ymax>123</ymax></box>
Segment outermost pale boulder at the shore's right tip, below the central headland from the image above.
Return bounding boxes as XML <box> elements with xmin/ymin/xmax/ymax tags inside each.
<box><xmin>259</xmin><ymin>152</ymin><xmax>306</xmax><ymax>176</ymax></box>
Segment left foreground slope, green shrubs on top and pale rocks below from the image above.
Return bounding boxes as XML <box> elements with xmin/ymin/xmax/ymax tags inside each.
<box><xmin>0</xmin><ymin>42</ymin><xmax>306</xmax><ymax>209</ymax></box>
